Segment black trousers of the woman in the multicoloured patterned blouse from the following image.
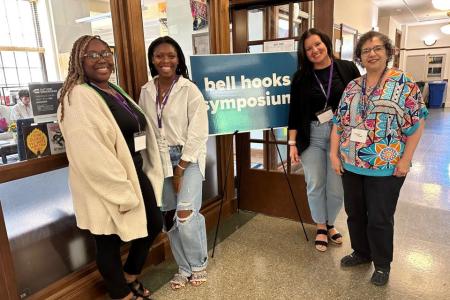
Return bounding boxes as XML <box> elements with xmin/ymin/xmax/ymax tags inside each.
<box><xmin>342</xmin><ymin>171</ymin><xmax>405</xmax><ymax>268</ymax></box>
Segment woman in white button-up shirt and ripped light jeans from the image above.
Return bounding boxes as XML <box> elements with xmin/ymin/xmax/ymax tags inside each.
<box><xmin>139</xmin><ymin>36</ymin><xmax>208</xmax><ymax>289</ymax></box>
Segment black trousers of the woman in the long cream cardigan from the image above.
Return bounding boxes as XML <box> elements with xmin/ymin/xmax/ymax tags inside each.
<box><xmin>94</xmin><ymin>172</ymin><xmax>162</xmax><ymax>299</ymax></box>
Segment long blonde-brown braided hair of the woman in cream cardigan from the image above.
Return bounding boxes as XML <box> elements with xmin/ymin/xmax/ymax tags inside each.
<box><xmin>59</xmin><ymin>35</ymin><xmax>109</xmax><ymax>122</ymax></box>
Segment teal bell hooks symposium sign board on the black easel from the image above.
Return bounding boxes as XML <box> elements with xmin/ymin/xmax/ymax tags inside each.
<box><xmin>191</xmin><ymin>52</ymin><xmax>297</xmax><ymax>135</ymax></box>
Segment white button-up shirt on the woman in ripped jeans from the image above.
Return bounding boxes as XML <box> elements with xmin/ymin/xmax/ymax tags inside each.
<box><xmin>139</xmin><ymin>76</ymin><xmax>208</xmax><ymax>177</ymax></box>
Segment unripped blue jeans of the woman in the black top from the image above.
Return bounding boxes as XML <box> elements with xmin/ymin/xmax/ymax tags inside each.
<box><xmin>301</xmin><ymin>122</ymin><xmax>344</xmax><ymax>225</ymax></box>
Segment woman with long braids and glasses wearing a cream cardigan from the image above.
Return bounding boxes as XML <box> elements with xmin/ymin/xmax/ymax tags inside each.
<box><xmin>58</xmin><ymin>35</ymin><xmax>163</xmax><ymax>299</ymax></box>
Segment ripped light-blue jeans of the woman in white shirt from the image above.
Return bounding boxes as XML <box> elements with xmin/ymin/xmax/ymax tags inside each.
<box><xmin>161</xmin><ymin>147</ymin><xmax>208</xmax><ymax>277</ymax></box>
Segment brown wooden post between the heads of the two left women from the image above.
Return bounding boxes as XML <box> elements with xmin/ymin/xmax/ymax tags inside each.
<box><xmin>110</xmin><ymin>0</ymin><xmax>148</xmax><ymax>102</ymax></box>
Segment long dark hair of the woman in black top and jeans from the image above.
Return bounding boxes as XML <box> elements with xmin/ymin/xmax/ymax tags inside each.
<box><xmin>297</xmin><ymin>28</ymin><xmax>334</xmax><ymax>76</ymax></box>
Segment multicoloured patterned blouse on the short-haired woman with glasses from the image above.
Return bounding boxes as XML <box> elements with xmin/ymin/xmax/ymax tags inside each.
<box><xmin>333</xmin><ymin>69</ymin><xmax>428</xmax><ymax>176</ymax></box>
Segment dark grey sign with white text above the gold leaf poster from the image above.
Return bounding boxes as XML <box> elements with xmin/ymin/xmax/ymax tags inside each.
<box><xmin>28</xmin><ymin>82</ymin><xmax>63</xmax><ymax>123</ymax></box>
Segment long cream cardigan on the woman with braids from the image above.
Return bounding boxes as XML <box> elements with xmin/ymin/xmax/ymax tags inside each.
<box><xmin>58</xmin><ymin>84</ymin><xmax>164</xmax><ymax>241</ymax></box>
